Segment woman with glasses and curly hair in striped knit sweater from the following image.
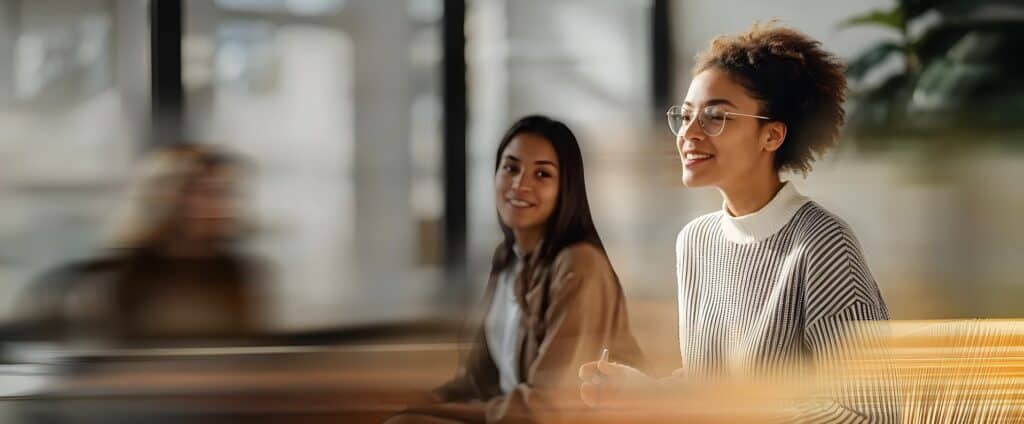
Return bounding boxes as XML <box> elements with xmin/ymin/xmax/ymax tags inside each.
<box><xmin>580</xmin><ymin>24</ymin><xmax>897</xmax><ymax>422</ymax></box>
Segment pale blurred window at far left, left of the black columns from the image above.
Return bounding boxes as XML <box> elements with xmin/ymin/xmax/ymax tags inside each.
<box><xmin>0</xmin><ymin>0</ymin><xmax>150</xmax><ymax>316</ymax></box>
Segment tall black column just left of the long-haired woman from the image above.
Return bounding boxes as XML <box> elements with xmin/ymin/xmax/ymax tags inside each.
<box><xmin>441</xmin><ymin>0</ymin><xmax>468</xmax><ymax>289</ymax></box>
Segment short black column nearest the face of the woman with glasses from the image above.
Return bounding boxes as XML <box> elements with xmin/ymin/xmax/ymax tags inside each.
<box><xmin>650</xmin><ymin>0</ymin><xmax>677</xmax><ymax>117</ymax></box>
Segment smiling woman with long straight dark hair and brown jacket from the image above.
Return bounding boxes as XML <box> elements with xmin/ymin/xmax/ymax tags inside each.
<box><xmin>389</xmin><ymin>116</ymin><xmax>644</xmax><ymax>423</ymax></box>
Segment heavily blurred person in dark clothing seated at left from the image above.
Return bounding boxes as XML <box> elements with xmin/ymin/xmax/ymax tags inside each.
<box><xmin>19</xmin><ymin>144</ymin><xmax>262</xmax><ymax>341</ymax></box>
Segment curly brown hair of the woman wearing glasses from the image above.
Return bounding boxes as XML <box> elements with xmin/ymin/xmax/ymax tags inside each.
<box><xmin>693</xmin><ymin>22</ymin><xmax>846</xmax><ymax>175</ymax></box>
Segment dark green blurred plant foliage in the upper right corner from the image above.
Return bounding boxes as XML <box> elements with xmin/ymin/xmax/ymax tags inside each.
<box><xmin>840</xmin><ymin>0</ymin><xmax>1024</xmax><ymax>151</ymax></box>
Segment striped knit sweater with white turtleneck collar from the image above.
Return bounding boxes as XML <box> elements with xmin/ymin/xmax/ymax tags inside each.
<box><xmin>676</xmin><ymin>183</ymin><xmax>896</xmax><ymax>422</ymax></box>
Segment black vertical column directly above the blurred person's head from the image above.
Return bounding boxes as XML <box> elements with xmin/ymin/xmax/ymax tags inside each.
<box><xmin>150</xmin><ymin>0</ymin><xmax>184</xmax><ymax>145</ymax></box>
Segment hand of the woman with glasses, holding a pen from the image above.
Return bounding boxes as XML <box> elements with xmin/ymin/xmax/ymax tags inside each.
<box><xmin>580</xmin><ymin>358</ymin><xmax>654</xmax><ymax>407</ymax></box>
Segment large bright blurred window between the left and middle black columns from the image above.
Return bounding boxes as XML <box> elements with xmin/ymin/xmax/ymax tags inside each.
<box><xmin>183</xmin><ymin>0</ymin><xmax>442</xmax><ymax>330</ymax></box>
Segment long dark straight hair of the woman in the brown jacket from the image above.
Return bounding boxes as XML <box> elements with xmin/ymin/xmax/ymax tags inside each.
<box><xmin>492</xmin><ymin>115</ymin><xmax>607</xmax><ymax>289</ymax></box>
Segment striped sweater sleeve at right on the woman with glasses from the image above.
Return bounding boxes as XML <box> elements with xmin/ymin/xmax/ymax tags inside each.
<box><xmin>798</xmin><ymin>218</ymin><xmax>899</xmax><ymax>423</ymax></box>
